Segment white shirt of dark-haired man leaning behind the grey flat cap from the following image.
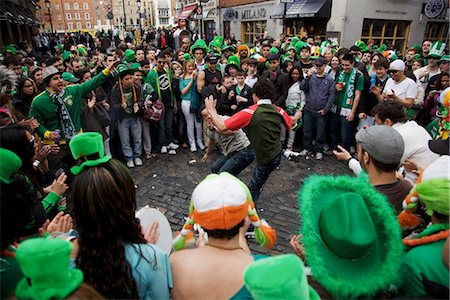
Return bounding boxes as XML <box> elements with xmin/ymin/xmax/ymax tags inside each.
<box><xmin>392</xmin><ymin>121</ymin><xmax>439</xmax><ymax>184</ymax></box>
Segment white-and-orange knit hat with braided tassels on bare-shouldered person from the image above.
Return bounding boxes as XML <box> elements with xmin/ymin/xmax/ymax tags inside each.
<box><xmin>173</xmin><ymin>172</ymin><xmax>276</xmax><ymax>250</ymax></box>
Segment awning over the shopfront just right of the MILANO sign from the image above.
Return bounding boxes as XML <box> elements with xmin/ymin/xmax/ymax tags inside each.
<box><xmin>286</xmin><ymin>0</ymin><xmax>331</xmax><ymax>18</ymax></box>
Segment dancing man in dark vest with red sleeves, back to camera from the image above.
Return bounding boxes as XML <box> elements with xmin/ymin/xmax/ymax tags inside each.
<box><xmin>205</xmin><ymin>80</ymin><xmax>300</xmax><ymax>202</ymax></box>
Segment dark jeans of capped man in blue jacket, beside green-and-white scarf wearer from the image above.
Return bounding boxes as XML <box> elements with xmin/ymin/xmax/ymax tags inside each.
<box><xmin>303</xmin><ymin>109</ymin><xmax>327</xmax><ymax>153</ymax></box>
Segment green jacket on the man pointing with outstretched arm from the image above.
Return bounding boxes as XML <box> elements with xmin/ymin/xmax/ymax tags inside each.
<box><xmin>29</xmin><ymin>71</ymin><xmax>108</xmax><ymax>144</ymax></box>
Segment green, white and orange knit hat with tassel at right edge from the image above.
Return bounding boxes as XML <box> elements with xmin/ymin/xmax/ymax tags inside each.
<box><xmin>398</xmin><ymin>155</ymin><xmax>450</xmax><ymax>228</ymax></box>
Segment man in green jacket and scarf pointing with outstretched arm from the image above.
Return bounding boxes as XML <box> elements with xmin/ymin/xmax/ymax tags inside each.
<box><xmin>29</xmin><ymin>61</ymin><xmax>118</xmax><ymax>171</ymax></box>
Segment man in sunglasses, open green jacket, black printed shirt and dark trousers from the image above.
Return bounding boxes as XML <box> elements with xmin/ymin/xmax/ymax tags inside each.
<box><xmin>147</xmin><ymin>53</ymin><xmax>179</xmax><ymax>154</ymax></box>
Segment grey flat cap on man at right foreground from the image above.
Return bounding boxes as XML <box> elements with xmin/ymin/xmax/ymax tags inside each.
<box><xmin>355</xmin><ymin>125</ymin><xmax>405</xmax><ymax>164</ymax></box>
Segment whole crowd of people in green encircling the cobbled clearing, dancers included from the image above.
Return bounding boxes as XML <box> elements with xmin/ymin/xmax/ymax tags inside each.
<box><xmin>0</xmin><ymin>29</ymin><xmax>450</xmax><ymax>299</ymax></box>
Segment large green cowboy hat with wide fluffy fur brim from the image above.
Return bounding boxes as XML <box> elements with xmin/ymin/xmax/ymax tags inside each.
<box><xmin>299</xmin><ymin>175</ymin><xmax>403</xmax><ymax>299</ymax></box>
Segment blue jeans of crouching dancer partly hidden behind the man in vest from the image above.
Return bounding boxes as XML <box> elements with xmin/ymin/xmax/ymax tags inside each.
<box><xmin>211</xmin><ymin>146</ymin><xmax>255</xmax><ymax>176</ymax></box>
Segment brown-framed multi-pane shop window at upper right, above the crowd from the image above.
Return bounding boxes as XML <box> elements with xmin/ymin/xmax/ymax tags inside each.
<box><xmin>361</xmin><ymin>19</ymin><xmax>411</xmax><ymax>53</ymax></box>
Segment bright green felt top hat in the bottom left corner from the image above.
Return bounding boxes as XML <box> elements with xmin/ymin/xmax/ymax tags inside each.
<box><xmin>16</xmin><ymin>238</ymin><xmax>83</xmax><ymax>300</ymax></box>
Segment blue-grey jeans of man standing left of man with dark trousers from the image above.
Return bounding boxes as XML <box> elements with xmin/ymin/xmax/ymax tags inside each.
<box><xmin>119</xmin><ymin>117</ymin><xmax>142</xmax><ymax>161</ymax></box>
